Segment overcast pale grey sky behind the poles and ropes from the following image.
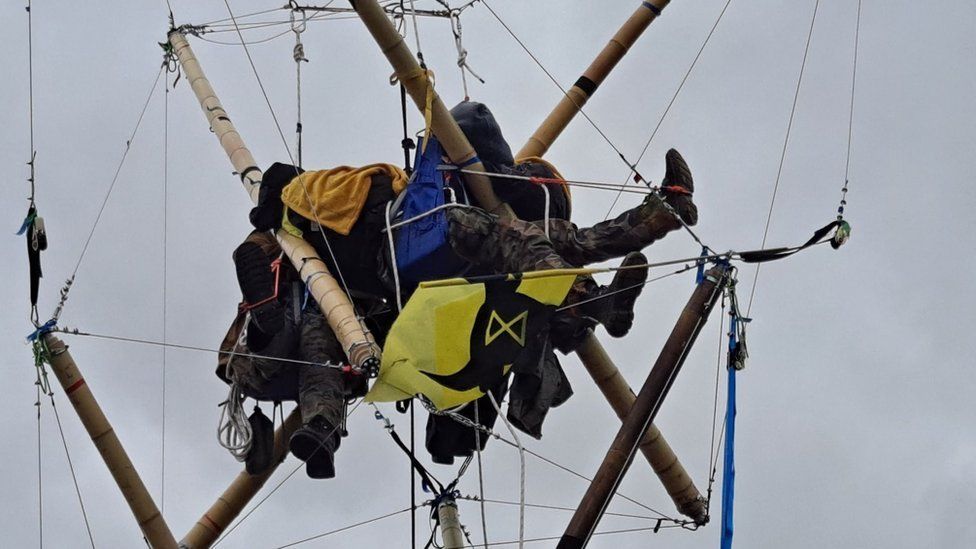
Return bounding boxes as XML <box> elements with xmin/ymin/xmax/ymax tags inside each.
<box><xmin>0</xmin><ymin>0</ymin><xmax>976</xmax><ymax>548</ymax></box>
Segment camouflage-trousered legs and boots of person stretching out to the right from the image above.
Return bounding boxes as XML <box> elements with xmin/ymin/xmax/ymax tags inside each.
<box><xmin>447</xmin><ymin>149</ymin><xmax>698</xmax><ymax>344</ymax></box>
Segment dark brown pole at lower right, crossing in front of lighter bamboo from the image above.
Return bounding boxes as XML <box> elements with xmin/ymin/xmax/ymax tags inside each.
<box><xmin>557</xmin><ymin>265</ymin><xmax>729</xmax><ymax>549</ymax></box>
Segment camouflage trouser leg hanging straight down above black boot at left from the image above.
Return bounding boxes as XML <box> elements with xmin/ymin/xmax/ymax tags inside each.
<box><xmin>298</xmin><ymin>307</ymin><xmax>345</xmax><ymax>427</ymax></box>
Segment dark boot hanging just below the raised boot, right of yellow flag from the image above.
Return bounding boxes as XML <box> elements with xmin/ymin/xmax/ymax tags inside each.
<box><xmin>579</xmin><ymin>252</ymin><xmax>648</xmax><ymax>337</ymax></box>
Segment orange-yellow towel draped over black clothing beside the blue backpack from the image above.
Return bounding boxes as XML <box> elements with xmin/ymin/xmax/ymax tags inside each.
<box><xmin>281</xmin><ymin>164</ymin><xmax>407</xmax><ymax>235</ymax></box>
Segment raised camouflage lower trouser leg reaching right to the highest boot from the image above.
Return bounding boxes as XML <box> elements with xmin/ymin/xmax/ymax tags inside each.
<box><xmin>534</xmin><ymin>196</ymin><xmax>681</xmax><ymax>267</ymax></box>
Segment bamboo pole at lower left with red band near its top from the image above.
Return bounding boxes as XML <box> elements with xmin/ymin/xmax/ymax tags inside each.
<box><xmin>43</xmin><ymin>333</ymin><xmax>177</xmax><ymax>549</ymax></box>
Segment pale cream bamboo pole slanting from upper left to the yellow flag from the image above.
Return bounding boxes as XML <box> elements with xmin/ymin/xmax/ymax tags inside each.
<box><xmin>169</xmin><ymin>30</ymin><xmax>380</xmax><ymax>370</ymax></box>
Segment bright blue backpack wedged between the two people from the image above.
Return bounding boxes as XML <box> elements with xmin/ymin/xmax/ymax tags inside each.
<box><xmin>395</xmin><ymin>137</ymin><xmax>468</xmax><ymax>291</ymax></box>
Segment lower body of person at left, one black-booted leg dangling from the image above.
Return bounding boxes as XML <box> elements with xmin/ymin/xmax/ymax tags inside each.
<box><xmin>218</xmin><ymin>231</ymin><xmax>356</xmax><ymax>478</ymax></box>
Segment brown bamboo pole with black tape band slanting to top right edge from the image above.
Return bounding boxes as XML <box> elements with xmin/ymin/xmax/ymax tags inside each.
<box><xmin>516</xmin><ymin>0</ymin><xmax>671</xmax><ymax>158</ymax></box>
